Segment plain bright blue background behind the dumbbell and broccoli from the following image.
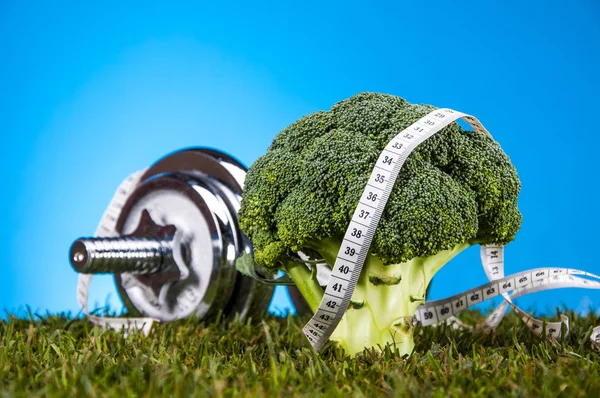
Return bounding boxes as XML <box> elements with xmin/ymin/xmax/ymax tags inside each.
<box><xmin>0</xmin><ymin>0</ymin><xmax>600</xmax><ymax>320</ymax></box>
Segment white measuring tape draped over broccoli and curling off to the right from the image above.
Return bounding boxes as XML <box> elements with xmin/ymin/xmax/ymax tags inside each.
<box><xmin>302</xmin><ymin>108</ymin><xmax>600</xmax><ymax>351</ymax></box>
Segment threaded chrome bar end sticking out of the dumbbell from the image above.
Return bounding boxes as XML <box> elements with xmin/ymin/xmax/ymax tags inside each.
<box><xmin>70</xmin><ymin>237</ymin><xmax>179</xmax><ymax>275</ymax></box>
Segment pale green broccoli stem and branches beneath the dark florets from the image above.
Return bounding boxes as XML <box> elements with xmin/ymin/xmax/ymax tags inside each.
<box><xmin>286</xmin><ymin>238</ymin><xmax>476</xmax><ymax>355</ymax></box>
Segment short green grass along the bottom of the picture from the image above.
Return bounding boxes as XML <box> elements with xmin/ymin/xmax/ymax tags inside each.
<box><xmin>0</xmin><ymin>312</ymin><xmax>600</xmax><ymax>397</ymax></box>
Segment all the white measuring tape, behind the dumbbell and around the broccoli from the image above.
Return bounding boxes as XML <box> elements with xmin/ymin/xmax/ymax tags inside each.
<box><xmin>77</xmin><ymin>108</ymin><xmax>600</xmax><ymax>351</ymax></box>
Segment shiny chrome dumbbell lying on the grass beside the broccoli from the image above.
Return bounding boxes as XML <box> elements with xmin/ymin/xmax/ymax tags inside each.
<box><xmin>69</xmin><ymin>148</ymin><xmax>273</xmax><ymax>322</ymax></box>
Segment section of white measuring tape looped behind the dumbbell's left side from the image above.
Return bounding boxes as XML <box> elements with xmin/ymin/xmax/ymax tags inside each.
<box><xmin>77</xmin><ymin>170</ymin><xmax>156</xmax><ymax>336</ymax></box>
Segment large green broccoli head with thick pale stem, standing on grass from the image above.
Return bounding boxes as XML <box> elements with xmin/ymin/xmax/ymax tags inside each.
<box><xmin>239</xmin><ymin>93</ymin><xmax>521</xmax><ymax>355</ymax></box>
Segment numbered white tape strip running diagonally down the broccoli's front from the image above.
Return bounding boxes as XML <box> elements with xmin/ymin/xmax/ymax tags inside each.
<box><xmin>302</xmin><ymin>108</ymin><xmax>491</xmax><ymax>351</ymax></box>
